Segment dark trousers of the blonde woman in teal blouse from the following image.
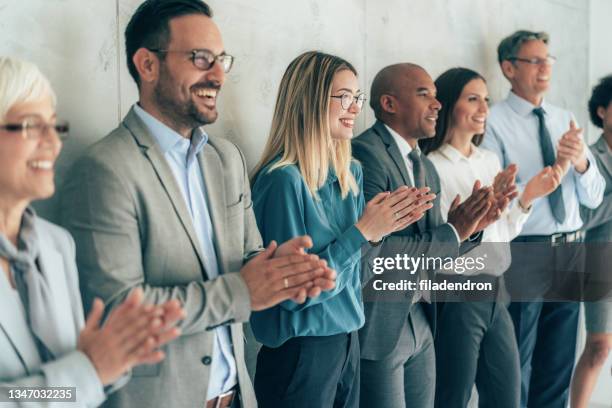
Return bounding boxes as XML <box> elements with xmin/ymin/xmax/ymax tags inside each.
<box><xmin>255</xmin><ymin>332</ymin><xmax>359</xmax><ymax>408</ymax></box>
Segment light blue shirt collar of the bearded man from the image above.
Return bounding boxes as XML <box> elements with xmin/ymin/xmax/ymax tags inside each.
<box><xmin>134</xmin><ymin>104</ymin><xmax>208</xmax><ymax>156</ymax></box>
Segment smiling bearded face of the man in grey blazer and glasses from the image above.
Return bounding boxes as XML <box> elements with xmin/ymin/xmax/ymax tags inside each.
<box><xmin>152</xmin><ymin>14</ymin><xmax>225</xmax><ymax>133</ymax></box>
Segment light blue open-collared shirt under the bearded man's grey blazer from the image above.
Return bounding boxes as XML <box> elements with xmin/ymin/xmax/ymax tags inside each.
<box><xmin>134</xmin><ymin>105</ymin><xmax>237</xmax><ymax>399</ymax></box>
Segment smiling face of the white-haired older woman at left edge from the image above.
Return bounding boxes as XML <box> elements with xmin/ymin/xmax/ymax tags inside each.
<box><xmin>0</xmin><ymin>96</ymin><xmax>62</xmax><ymax>206</ymax></box>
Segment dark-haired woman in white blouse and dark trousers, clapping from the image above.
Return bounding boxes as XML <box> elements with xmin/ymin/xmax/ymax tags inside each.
<box><xmin>421</xmin><ymin>68</ymin><xmax>562</xmax><ymax>408</ymax></box>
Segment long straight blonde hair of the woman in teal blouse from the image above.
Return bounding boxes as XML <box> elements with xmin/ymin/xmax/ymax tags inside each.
<box><xmin>252</xmin><ymin>51</ymin><xmax>359</xmax><ymax>199</ymax></box>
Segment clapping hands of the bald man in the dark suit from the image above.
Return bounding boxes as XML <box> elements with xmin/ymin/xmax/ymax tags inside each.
<box><xmin>448</xmin><ymin>180</ymin><xmax>494</xmax><ymax>241</ymax></box>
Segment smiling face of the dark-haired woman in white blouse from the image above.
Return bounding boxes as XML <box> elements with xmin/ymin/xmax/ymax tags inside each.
<box><xmin>451</xmin><ymin>78</ymin><xmax>489</xmax><ymax>136</ymax></box>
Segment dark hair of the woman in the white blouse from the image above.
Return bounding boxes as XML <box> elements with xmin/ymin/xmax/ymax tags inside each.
<box><xmin>419</xmin><ymin>68</ymin><xmax>487</xmax><ymax>154</ymax></box>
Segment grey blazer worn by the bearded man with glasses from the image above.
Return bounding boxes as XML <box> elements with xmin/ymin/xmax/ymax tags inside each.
<box><xmin>61</xmin><ymin>110</ymin><xmax>261</xmax><ymax>408</ymax></box>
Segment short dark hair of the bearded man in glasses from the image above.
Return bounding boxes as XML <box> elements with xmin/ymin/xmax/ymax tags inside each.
<box><xmin>125</xmin><ymin>0</ymin><xmax>213</xmax><ymax>85</ymax></box>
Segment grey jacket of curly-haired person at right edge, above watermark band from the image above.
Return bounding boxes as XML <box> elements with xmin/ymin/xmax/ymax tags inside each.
<box><xmin>580</xmin><ymin>136</ymin><xmax>612</xmax><ymax>242</ymax></box>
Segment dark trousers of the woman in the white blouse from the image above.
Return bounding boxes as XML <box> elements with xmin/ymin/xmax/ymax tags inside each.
<box><xmin>435</xmin><ymin>302</ymin><xmax>521</xmax><ymax>408</ymax></box>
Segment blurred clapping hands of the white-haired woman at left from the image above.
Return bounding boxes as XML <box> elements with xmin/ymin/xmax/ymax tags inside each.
<box><xmin>77</xmin><ymin>288</ymin><xmax>185</xmax><ymax>385</ymax></box>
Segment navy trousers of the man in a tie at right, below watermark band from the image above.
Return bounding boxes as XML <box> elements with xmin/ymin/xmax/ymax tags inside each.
<box><xmin>509</xmin><ymin>302</ymin><xmax>580</xmax><ymax>408</ymax></box>
